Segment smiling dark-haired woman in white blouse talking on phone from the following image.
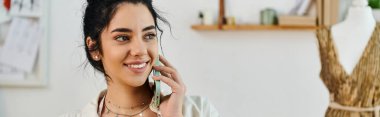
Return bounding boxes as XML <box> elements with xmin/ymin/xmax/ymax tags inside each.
<box><xmin>60</xmin><ymin>0</ymin><xmax>219</xmax><ymax>117</ymax></box>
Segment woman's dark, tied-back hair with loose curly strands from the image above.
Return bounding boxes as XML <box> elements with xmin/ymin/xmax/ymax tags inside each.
<box><xmin>83</xmin><ymin>0</ymin><xmax>170</xmax><ymax>79</ymax></box>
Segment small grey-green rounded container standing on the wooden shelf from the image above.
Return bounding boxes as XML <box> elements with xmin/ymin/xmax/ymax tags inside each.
<box><xmin>260</xmin><ymin>8</ymin><xmax>277</xmax><ymax>25</ymax></box>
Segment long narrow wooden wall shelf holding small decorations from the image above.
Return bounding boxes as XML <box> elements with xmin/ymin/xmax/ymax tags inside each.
<box><xmin>191</xmin><ymin>25</ymin><xmax>318</xmax><ymax>31</ymax></box>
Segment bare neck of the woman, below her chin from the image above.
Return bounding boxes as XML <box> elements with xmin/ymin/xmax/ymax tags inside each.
<box><xmin>106</xmin><ymin>82</ymin><xmax>153</xmax><ymax>107</ymax></box>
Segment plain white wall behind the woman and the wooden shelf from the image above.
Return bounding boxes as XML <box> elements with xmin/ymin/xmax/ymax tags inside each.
<box><xmin>0</xmin><ymin>0</ymin><xmax>328</xmax><ymax>117</ymax></box>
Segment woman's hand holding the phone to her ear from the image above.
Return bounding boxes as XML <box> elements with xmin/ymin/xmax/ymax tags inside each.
<box><xmin>153</xmin><ymin>55</ymin><xmax>186</xmax><ymax>117</ymax></box>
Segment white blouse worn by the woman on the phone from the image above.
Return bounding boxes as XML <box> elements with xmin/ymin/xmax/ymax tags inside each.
<box><xmin>60</xmin><ymin>91</ymin><xmax>219</xmax><ymax>117</ymax></box>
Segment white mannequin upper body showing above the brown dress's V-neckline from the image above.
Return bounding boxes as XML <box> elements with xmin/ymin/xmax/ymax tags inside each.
<box><xmin>331</xmin><ymin>0</ymin><xmax>376</xmax><ymax>75</ymax></box>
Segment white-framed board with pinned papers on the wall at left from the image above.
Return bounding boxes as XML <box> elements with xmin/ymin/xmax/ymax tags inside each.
<box><xmin>0</xmin><ymin>0</ymin><xmax>49</xmax><ymax>87</ymax></box>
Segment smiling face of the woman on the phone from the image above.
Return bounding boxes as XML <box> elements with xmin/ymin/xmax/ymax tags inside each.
<box><xmin>101</xmin><ymin>3</ymin><xmax>158</xmax><ymax>87</ymax></box>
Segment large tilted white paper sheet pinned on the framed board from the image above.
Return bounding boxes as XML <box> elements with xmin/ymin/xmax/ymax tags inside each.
<box><xmin>0</xmin><ymin>18</ymin><xmax>42</xmax><ymax>73</ymax></box>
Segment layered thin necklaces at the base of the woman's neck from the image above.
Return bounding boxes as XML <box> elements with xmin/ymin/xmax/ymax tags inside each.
<box><xmin>104</xmin><ymin>100</ymin><xmax>149</xmax><ymax>117</ymax></box>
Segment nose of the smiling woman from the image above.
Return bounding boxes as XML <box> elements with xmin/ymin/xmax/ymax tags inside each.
<box><xmin>130</xmin><ymin>38</ymin><xmax>148</xmax><ymax>56</ymax></box>
